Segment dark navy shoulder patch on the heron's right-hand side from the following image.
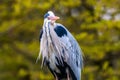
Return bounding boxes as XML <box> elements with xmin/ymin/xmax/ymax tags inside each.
<box><xmin>54</xmin><ymin>24</ymin><xmax>67</xmax><ymax>37</ymax></box>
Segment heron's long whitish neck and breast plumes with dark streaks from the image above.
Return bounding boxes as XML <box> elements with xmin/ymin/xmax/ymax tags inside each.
<box><xmin>39</xmin><ymin>20</ymin><xmax>66</xmax><ymax>65</ymax></box>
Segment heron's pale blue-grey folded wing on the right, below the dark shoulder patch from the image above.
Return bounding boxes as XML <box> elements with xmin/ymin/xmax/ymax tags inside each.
<box><xmin>57</xmin><ymin>24</ymin><xmax>83</xmax><ymax>68</ymax></box>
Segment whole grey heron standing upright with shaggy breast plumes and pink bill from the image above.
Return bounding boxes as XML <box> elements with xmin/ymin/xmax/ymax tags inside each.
<box><xmin>38</xmin><ymin>11</ymin><xmax>83</xmax><ymax>80</ymax></box>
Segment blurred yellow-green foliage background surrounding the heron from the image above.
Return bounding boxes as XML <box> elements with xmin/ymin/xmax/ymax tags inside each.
<box><xmin>0</xmin><ymin>0</ymin><xmax>120</xmax><ymax>80</ymax></box>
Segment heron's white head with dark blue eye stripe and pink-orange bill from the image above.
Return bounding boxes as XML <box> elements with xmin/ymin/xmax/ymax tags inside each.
<box><xmin>44</xmin><ymin>11</ymin><xmax>60</xmax><ymax>24</ymax></box>
